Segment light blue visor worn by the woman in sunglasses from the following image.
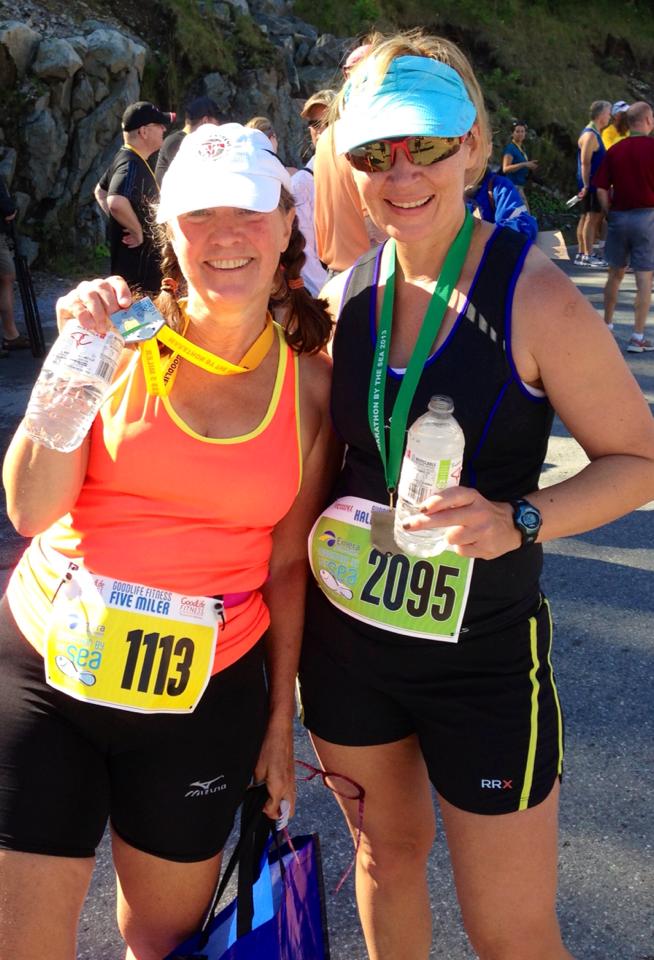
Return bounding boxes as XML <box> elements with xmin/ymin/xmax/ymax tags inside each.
<box><xmin>334</xmin><ymin>54</ymin><xmax>477</xmax><ymax>153</ymax></box>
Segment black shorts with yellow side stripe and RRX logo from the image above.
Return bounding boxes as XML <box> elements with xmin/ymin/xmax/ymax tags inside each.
<box><xmin>300</xmin><ymin>583</ymin><xmax>563</xmax><ymax>814</ymax></box>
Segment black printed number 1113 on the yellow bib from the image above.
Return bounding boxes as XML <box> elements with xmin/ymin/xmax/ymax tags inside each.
<box><xmin>120</xmin><ymin>630</ymin><xmax>195</xmax><ymax>697</ymax></box>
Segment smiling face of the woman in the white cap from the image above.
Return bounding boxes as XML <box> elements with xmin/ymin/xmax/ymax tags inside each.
<box><xmin>169</xmin><ymin>207</ymin><xmax>295</xmax><ymax>310</ymax></box>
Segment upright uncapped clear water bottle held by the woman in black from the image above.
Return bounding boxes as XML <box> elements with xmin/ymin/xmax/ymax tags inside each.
<box><xmin>393</xmin><ymin>397</ymin><xmax>465</xmax><ymax>557</ymax></box>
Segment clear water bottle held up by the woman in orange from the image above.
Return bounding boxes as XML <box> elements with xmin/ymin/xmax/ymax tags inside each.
<box><xmin>23</xmin><ymin>321</ymin><xmax>124</xmax><ymax>453</ymax></box>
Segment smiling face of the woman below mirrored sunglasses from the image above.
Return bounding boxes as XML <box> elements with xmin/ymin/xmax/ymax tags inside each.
<box><xmin>352</xmin><ymin>127</ymin><xmax>480</xmax><ymax>243</ymax></box>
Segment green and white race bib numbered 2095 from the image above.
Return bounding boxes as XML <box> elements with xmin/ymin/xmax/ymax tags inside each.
<box><xmin>309</xmin><ymin>497</ymin><xmax>474</xmax><ymax>643</ymax></box>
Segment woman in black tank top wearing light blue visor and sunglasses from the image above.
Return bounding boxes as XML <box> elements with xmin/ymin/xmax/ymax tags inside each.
<box><xmin>300</xmin><ymin>32</ymin><xmax>654</xmax><ymax>960</ymax></box>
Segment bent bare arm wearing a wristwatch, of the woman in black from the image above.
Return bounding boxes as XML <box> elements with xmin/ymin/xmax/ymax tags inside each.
<box><xmin>404</xmin><ymin>250</ymin><xmax>654</xmax><ymax>559</ymax></box>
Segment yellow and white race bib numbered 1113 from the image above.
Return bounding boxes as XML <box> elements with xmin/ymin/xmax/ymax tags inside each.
<box><xmin>44</xmin><ymin>563</ymin><xmax>223</xmax><ymax>713</ymax></box>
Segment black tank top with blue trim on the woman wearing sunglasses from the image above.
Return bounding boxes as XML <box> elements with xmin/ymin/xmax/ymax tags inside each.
<box><xmin>332</xmin><ymin>228</ymin><xmax>553</xmax><ymax>633</ymax></box>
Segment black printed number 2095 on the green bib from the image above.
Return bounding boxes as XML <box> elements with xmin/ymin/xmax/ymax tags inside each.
<box><xmin>361</xmin><ymin>549</ymin><xmax>460</xmax><ymax>622</ymax></box>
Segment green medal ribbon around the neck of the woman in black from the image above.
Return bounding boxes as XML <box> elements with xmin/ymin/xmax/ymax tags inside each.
<box><xmin>368</xmin><ymin>210</ymin><xmax>474</xmax><ymax>506</ymax></box>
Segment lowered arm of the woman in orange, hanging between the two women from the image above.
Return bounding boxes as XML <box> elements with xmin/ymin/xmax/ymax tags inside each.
<box><xmin>255</xmin><ymin>354</ymin><xmax>340</xmax><ymax>817</ymax></box>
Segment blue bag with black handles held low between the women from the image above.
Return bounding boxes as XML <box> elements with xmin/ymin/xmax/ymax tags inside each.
<box><xmin>166</xmin><ymin>788</ymin><xmax>329</xmax><ymax>960</ymax></box>
